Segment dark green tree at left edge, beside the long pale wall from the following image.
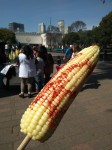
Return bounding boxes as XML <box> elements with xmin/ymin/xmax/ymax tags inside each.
<box><xmin>0</xmin><ymin>29</ymin><xmax>16</xmax><ymax>44</ymax></box>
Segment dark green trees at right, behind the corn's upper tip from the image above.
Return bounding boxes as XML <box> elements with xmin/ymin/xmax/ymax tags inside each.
<box><xmin>63</xmin><ymin>12</ymin><xmax>112</xmax><ymax>47</ymax></box>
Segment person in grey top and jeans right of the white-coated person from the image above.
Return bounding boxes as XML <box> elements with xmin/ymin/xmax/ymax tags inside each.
<box><xmin>35</xmin><ymin>51</ymin><xmax>45</xmax><ymax>92</ymax></box>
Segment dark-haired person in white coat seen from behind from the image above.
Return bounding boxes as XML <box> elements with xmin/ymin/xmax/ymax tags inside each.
<box><xmin>18</xmin><ymin>45</ymin><xmax>36</xmax><ymax>98</ymax></box>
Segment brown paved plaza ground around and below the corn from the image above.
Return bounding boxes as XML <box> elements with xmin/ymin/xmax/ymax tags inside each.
<box><xmin>0</xmin><ymin>61</ymin><xmax>112</xmax><ymax>150</ymax></box>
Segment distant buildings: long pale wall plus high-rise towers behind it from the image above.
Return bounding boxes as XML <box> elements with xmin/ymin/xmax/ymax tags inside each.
<box><xmin>12</xmin><ymin>20</ymin><xmax>65</xmax><ymax>47</ymax></box>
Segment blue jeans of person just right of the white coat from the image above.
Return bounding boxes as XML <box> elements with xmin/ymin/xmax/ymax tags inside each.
<box><xmin>35</xmin><ymin>74</ymin><xmax>44</xmax><ymax>92</ymax></box>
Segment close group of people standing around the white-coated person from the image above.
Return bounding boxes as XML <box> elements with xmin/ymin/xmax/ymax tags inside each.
<box><xmin>17</xmin><ymin>45</ymin><xmax>54</xmax><ymax>98</ymax></box>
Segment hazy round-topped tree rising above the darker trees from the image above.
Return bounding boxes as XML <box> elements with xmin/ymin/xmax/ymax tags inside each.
<box><xmin>70</xmin><ymin>21</ymin><xmax>86</xmax><ymax>32</ymax></box>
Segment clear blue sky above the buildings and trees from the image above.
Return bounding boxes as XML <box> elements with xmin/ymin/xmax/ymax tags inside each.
<box><xmin>0</xmin><ymin>0</ymin><xmax>112</xmax><ymax>32</ymax></box>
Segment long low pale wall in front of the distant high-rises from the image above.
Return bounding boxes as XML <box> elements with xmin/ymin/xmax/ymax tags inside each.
<box><xmin>15</xmin><ymin>32</ymin><xmax>62</xmax><ymax>47</ymax></box>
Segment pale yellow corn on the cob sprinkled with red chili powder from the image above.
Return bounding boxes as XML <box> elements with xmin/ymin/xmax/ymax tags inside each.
<box><xmin>20</xmin><ymin>45</ymin><xmax>99</xmax><ymax>140</ymax></box>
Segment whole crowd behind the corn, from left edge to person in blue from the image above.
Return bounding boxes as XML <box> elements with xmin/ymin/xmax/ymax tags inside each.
<box><xmin>0</xmin><ymin>41</ymin><xmax>77</xmax><ymax>98</ymax></box>
